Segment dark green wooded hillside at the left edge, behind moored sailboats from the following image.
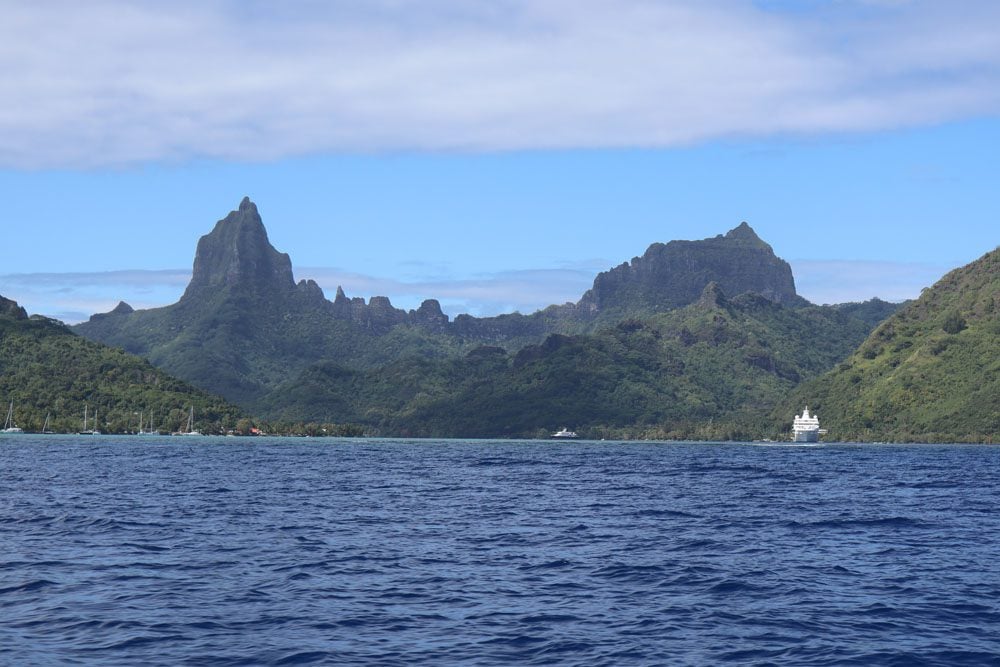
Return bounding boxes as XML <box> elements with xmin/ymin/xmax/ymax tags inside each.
<box><xmin>0</xmin><ymin>297</ymin><xmax>244</xmax><ymax>433</ymax></box>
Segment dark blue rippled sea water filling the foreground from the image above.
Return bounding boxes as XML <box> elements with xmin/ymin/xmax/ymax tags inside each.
<box><xmin>0</xmin><ymin>436</ymin><xmax>1000</xmax><ymax>666</ymax></box>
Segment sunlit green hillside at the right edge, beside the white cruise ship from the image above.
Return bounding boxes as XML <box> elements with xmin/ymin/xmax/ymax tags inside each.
<box><xmin>775</xmin><ymin>249</ymin><xmax>1000</xmax><ymax>442</ymax></box>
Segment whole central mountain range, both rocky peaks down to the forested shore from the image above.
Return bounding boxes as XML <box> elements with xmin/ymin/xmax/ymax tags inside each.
<box><xmin>75</xmin><ymin>199</ymin><xmax>912</xmax><ymax>437</ymax></box>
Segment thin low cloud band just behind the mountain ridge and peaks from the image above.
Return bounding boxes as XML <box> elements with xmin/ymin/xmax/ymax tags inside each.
<box><xmin>0</xmin><ymin>260</ymin><xmax>954</xmax><ymax>324</ymax></box>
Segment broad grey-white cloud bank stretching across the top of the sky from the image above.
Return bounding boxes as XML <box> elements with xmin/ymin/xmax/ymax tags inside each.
<box><xmin>0</xmin><ymin>0</ymin><xmax>1000</xmax><ymax>168</ymax></box>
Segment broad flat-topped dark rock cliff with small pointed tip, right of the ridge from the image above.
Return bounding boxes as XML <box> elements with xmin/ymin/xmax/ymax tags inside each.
<box><xmin>577</xmin><ymin>222</ymin><xmax>803</xmax><ymax>313</ymax></box>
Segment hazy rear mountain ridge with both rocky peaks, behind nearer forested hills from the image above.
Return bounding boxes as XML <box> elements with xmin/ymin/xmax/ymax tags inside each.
<box><xmin>76</xmin><ymin>198</ymin><xmax>892</xmax><ymax>418</ymax></box>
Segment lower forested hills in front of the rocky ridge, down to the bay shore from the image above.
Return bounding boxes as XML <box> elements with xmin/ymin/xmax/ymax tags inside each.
<box><xmin>258</xmin><ymin>284</ymin><xmax>868</xmax><ymax>437</ymax></box>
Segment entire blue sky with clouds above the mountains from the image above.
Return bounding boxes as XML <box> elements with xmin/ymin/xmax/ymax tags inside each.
<box><xmin>0</xmin><ymin>0</ymin><xmax>1000</xmax><ymax>323</ymax></box>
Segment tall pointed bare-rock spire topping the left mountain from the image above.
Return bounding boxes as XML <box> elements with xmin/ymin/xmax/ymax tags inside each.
<box><xmin>182</xmin><ymin>197</ymin><xmax>295</xmax><ymax>299</ymax></box>
